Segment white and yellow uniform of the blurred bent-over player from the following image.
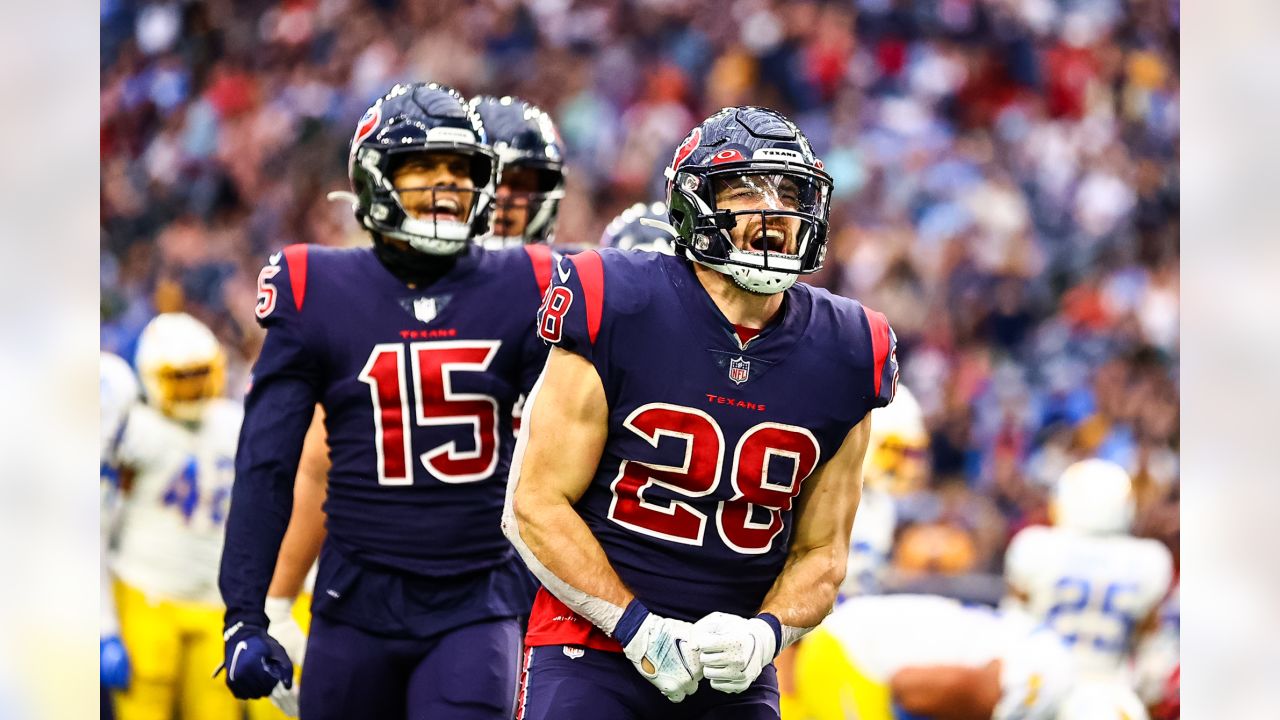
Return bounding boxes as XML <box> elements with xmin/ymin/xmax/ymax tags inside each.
<box><xmin>796</xmin><ymin>594</ymin><xmax>1074</xmax><ymax>720</ymax></box>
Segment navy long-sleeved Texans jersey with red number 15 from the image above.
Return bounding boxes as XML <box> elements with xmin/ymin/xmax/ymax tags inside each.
<box><xmin>221</xmin><ymin>245</ymin><xmax>553</xmax><ymax>624</ymax></box>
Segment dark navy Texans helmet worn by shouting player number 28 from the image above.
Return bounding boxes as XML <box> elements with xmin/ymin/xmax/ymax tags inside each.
<box><xmin>666</xmin><ymin>106</ymin><xmax>831</xmax><ymax>295</ymax></box>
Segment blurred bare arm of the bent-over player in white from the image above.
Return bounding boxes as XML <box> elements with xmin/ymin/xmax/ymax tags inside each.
<box><xmin>890</xmin><ymin>660</ymin><xmax>1001</xmax><ymax>720</ymax></box>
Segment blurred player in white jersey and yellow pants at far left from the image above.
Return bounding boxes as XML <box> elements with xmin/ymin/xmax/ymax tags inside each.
<box><xmin>104</xmin><ymin>313</ymin><xmax>243</xmax><ymax>720</ymax></box>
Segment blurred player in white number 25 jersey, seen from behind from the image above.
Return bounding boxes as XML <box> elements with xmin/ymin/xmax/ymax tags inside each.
<box><xmin>1004</xmin><ymin>459</ymin><xmax>1172</xmax><ymax>682</ymax></box>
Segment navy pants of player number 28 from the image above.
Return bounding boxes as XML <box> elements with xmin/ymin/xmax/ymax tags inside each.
<box><xmin>517</xmin><ymin>644</ymin><xmax>780</xmax><ymax>720</ymax></box>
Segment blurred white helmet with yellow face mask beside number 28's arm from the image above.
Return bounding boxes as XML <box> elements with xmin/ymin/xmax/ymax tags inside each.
<box><xmin>863</xmin><ymin>383</ymin><xmax>929</xmax><ymax>496</ymax></box>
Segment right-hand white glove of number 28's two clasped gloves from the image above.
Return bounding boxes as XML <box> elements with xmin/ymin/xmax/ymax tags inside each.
<box><xmin>694</xmin><ymin>612</ymin><xmax>777</xmax><ymax>693</ymax></box>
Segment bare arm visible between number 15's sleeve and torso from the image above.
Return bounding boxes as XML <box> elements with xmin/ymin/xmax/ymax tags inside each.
<box><xmin>266</xmin><ymin>405</ymin><xmax>329</xmax><ymax>605</ymax></box>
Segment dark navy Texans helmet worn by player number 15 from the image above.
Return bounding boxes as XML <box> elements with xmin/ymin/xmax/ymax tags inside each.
<box><xmin>347</xmin><ymin>82</ymin><xmax>498</xmax><ymax>256</ymax></box>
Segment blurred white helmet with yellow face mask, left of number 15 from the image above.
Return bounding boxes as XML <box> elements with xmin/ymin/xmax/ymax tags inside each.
<box><xmin>137</xmin><ymin>313</ymin><xmax>227</xmax><ymax>423</ymax></box>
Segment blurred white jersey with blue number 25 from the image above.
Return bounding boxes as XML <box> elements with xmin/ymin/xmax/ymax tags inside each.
<box><xmin>1005</xmin><ymin>527</ymin><xmax>1172</xmax><ymax>679</ymax></box>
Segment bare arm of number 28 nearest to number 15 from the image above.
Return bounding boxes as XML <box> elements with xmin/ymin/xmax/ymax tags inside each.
<box><xmin>506</xmin><ymin>347</ymin><xmax>635</xmax><ymax>614</ymax></box>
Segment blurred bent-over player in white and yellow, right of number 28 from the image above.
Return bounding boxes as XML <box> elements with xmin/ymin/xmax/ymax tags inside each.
<box><xmin>792</xmin><ymin>594</ymin><xmax>1075</xmax><ymax>720</ymax></box>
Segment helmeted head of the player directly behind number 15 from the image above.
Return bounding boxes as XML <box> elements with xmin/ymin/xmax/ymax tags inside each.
<box><xmin>471</xmin><ymin>95</ymin><xmax>564</xmax><ymax>249</ymax></box>
